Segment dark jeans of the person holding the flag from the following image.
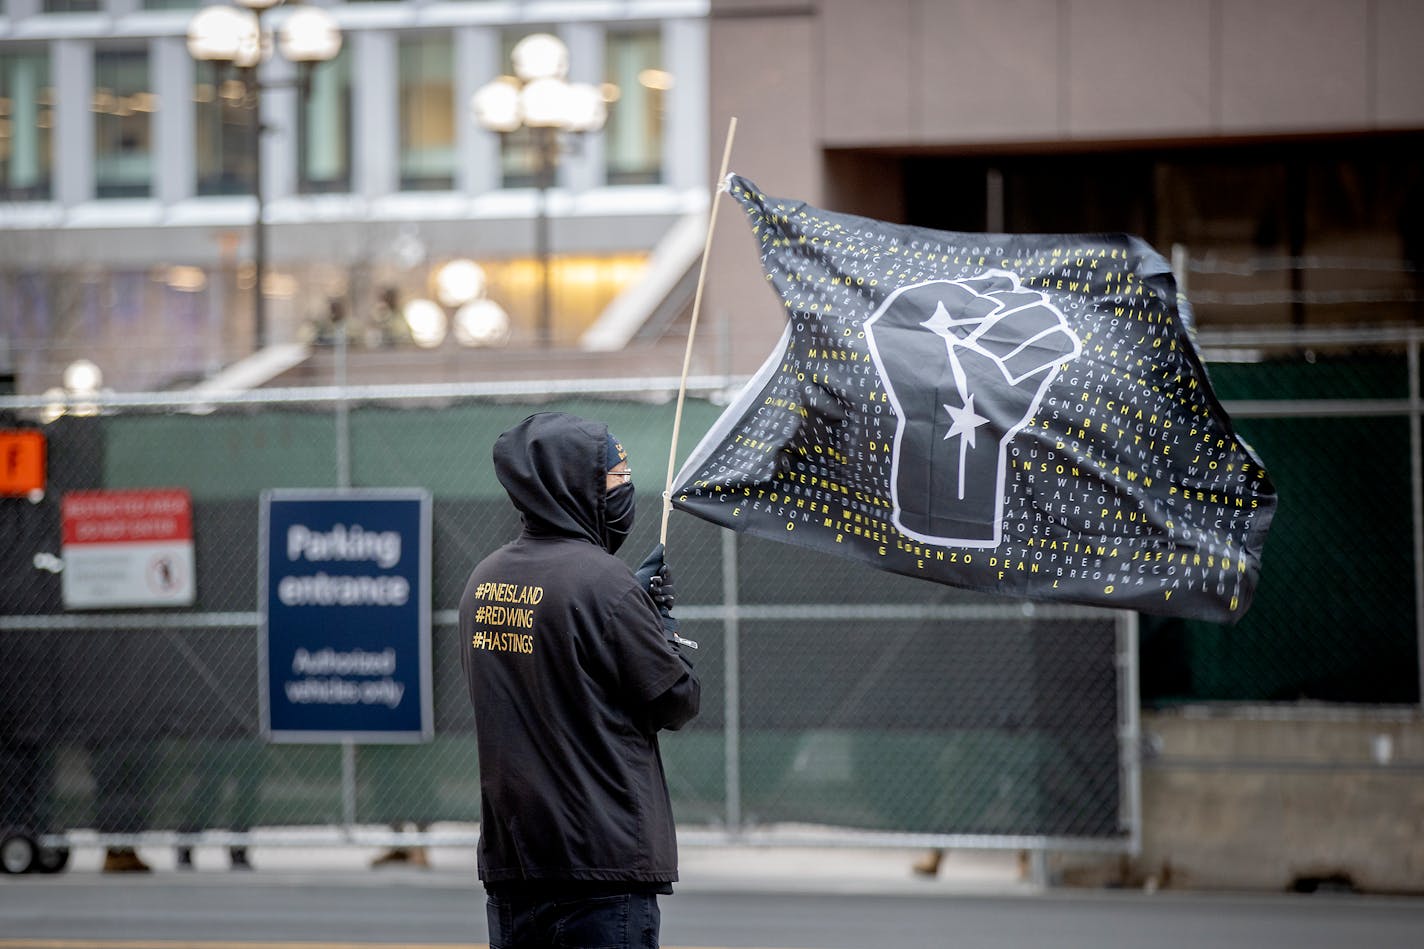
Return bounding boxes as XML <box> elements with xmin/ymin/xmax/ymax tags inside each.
<box><xmin>484</xmin><ymin>893</ymin><xmax>662</xmax><ymax>949</ymax></box>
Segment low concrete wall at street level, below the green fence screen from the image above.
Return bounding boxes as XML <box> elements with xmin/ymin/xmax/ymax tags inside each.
<box><xmin>1052</xmin><ymin>707</ymin><xmax>1424</xmax><ymax>893</ymax></box>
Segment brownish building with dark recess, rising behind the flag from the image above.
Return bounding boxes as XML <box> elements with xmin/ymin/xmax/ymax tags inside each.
<box><xmin>706</xmin><ymin>0</ymin><xmax>1424</xmax><ymax>370</ymax></box>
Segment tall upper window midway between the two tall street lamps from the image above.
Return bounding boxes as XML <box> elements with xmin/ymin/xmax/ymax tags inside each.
<box><xmin>400</xmin><ymin>34</ymin><xmax>456</xmax><ymax>191</ymax></box>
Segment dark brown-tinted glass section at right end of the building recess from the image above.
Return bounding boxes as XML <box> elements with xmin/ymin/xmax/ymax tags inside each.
<box><xmin>1155</xmin><ymin>134</ymin><xmax>1424</xmax><ymax>326</ymax></box>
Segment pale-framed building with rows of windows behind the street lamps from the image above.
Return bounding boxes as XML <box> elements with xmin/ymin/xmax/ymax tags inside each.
<box><xmin>0</xmin><ymin>0</ymin><xmax>708</xmax><ymax>392</ymax></box>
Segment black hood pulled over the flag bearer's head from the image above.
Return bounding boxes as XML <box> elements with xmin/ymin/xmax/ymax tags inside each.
<box><xmin>494</xmin><ymin>412</ymin><xmax>626</xmax><ymax>550</ymax></box>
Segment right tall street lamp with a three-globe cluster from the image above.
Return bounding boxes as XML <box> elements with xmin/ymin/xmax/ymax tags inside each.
<box><xmin>471</xmin><ymin>33</ymin><xmax>608</xmax><ymax>346</ymax></box>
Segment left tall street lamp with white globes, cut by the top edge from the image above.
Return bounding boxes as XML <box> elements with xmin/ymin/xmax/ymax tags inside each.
<box><xmin>188</xmin><ymin>0</ymin><xmax>342</xmax><ymax>351</ymax></box>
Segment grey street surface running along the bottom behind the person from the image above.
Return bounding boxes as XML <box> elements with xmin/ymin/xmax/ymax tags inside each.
<box><xmin>0</xmin><ymin>854</ymin><xmax>1424</xmax><ymax>949</ymax></box>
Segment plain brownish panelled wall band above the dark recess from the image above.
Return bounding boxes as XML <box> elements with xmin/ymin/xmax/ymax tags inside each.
<box><xmin>812</xmin><ymin>0</ymin><xmax>1424</xmax><ymax>147</ymax></box>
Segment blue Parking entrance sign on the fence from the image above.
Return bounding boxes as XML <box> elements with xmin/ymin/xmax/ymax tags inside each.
<box><xmin>259</xmin><ymin>489</ymin><xmax>433</xmax><ymax>742</ymax></box>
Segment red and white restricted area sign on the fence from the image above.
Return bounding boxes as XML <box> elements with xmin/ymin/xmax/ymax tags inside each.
<box><xmin>60</xmin><ymin>489</ymin><xmax>195</xmax><ymax>610</ymax></box>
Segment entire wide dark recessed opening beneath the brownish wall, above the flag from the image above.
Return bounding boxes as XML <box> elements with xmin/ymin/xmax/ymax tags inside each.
<box><xmin>901</xmin><ymin>133</ymin><xmax>1424</xmax><ymax>328</ymax></box>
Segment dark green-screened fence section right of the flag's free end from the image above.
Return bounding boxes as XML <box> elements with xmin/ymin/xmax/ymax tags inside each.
<box><xmin>1141</xmin><ymin>329</ymin><xmax>1424</xmax><ymax>705</ymax></box>
